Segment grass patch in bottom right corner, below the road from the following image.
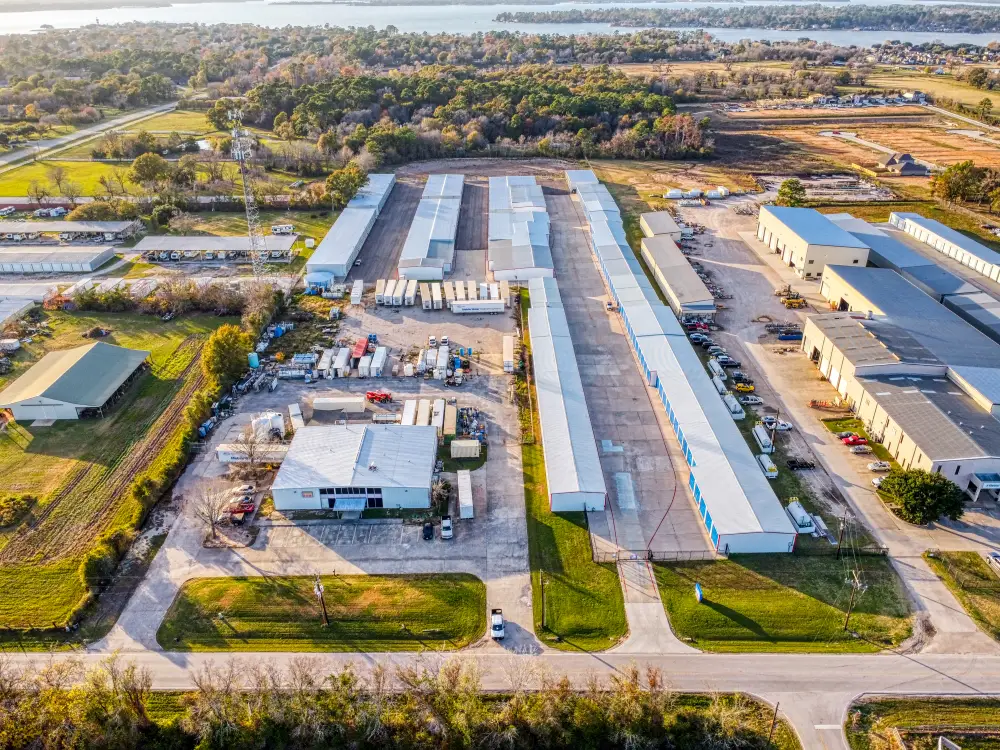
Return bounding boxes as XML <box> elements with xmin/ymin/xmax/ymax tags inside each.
<box><xmin>844</xmin><ymin>697</ymin><xmax>1000</xmax><ymax>750</ymax></box>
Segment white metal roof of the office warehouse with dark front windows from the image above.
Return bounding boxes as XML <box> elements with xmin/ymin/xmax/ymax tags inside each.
<box><xmin>272</xmin><ymin>424</ymin><xmax>437</xmax><ymax>496</ymax></box>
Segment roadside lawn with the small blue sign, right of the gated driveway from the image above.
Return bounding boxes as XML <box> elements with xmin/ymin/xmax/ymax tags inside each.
<box><xmin>653</xmin><ymin>555</ymin><xmax>911</xmax><ymax>653</ymax></box>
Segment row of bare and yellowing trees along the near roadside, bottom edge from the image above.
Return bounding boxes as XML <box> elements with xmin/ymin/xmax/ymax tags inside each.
<box><xmin>0</xmin><ymin>656</ymin><xmax>799</xmax><ymax>750</ymax></box>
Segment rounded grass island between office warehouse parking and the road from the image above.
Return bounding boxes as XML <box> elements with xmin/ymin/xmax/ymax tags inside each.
<box><xmin>156</xmin><ymin>573</ymin><xmax>486</xmax><ymax>651</ymax></box>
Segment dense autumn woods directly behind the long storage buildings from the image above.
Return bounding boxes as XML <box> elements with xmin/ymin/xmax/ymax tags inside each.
<box><xmin>208</xmin><ymin>66</ymin><xmax>712</xmax><ymax>163</ymax></box>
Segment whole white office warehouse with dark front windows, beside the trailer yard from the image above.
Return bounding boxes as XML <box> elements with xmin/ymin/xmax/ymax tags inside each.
<box><xmin>271</xmin><ymin>424</ymin><xmax>438</xmax><ymax>512</ymax></box>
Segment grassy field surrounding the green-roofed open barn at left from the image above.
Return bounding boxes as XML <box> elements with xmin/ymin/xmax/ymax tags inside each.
<box><xmin>0</xmin><ymin>312</ymin><xmax>227</xmax><ymax>627</ymax></box>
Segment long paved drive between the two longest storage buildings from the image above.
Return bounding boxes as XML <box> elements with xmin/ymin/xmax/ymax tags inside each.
<box><xmin>545</xmin><ymin>184</ymin><xmax>711</xmax><ymax>552</ymax></box>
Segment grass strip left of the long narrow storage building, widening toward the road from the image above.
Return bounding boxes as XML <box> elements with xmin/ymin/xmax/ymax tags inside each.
<box><xmin>521</xmin><ymin>290</ymin><xmax>628</xmax><ymax>651</ymax></box>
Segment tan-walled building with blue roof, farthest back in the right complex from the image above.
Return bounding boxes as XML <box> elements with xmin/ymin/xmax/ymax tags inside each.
<box><xmin>757</xmin><ymin>206</ymin><xmax>868</xmax><ymax>280</ymax></box>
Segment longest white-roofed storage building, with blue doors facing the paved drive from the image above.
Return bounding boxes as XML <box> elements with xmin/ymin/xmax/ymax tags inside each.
<box><xmin>571</xmin><ymin>172</ymin><xmax>796</xmax><ymax>553</ymax></box>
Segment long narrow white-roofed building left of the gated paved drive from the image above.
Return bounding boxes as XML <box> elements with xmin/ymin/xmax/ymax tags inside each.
<box><xmin>528</xmin><ymin>277</ymin><xmax>608</xmax><ymax>512</ymax></box>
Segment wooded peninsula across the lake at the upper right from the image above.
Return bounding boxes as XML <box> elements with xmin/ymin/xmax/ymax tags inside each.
<box><xmin>495</xmin><ymin>3</ymin><xmax>1000</xmax><ymax>33</ymax></box>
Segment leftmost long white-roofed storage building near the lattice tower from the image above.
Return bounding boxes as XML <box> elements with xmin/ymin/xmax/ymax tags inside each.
<box><xmin>306</xmin><ymin>174</ymin><xmax>396</xmax><ymax>279</ymax></box>
